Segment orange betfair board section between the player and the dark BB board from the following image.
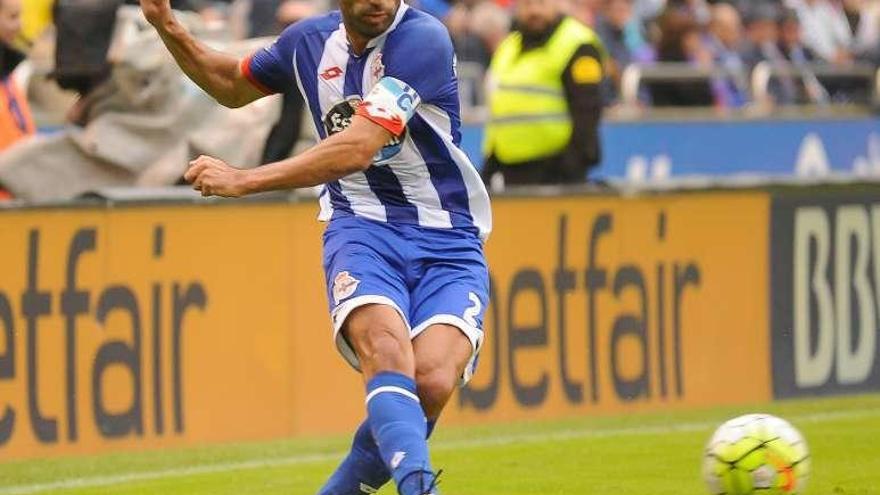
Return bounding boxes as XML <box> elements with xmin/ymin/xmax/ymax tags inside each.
<box><xmin>449</xmin><ymin>193</ymin><xmax>770</xmax><ymax>422</ymax></box>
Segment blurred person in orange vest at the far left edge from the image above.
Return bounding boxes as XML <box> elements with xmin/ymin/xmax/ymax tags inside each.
<box><xmin>0</xmin><ymin>0</ymin><xmax>34</xmax><ymax>151</ymax></box>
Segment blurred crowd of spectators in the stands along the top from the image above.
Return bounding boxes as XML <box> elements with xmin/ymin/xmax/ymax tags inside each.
<box><xmin>4</xmin><ymin>0</ymin><xmax>880</xmax><ymax>120</ymax></box>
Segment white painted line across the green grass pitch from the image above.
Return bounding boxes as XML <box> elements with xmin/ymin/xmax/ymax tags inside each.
<box><xmin>0</xmin><ymin>409</ymin><xmax>880</xmax><ymax>495</ymax></box>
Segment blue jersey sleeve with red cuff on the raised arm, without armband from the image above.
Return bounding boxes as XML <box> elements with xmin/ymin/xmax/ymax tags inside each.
<box><xmin>241</xmin><ymin>25</ymin><xmax>300</xmax><ymax>94</ymax></box>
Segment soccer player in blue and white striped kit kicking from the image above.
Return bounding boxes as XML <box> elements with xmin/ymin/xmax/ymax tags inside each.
<box><xmin>140</xmin><ymin>0</ymin><xmax>491</xmax><ymax>495</ymax></box>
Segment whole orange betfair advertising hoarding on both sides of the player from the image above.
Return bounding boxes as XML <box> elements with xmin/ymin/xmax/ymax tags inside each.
<box><xmin>0</xmin><ymin>193</ymin><xmax>770</xmax><ymax>461</ymax></box>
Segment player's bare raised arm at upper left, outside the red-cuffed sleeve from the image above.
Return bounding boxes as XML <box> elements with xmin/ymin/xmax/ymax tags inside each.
<box><xmin>140</xmin><ymin>0</ymin><xmax>266</xmax><ymax>108</ymax></box>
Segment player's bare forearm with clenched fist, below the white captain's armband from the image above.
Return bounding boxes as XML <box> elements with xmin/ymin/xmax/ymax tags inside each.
<box><xmin>184</xmin><ymin>115</ymin><xmax>393</xmax><ymax>198</ymax></box>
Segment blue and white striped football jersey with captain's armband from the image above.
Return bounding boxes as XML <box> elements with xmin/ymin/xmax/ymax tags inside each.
<box><xmin>242</xmin><ymin>2</ymin><xmax>492</xmax><ymax>239</ymax></box>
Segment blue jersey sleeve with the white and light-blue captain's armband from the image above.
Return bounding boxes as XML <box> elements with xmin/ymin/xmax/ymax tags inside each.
<box><xmin>357</xmin><ymin>16</ymin><xmax>457</xmax><ymax>136</ymax></box>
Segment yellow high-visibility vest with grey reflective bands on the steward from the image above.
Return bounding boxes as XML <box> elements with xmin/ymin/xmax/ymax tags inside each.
<box><xmin>483</xmin><ymin>17</ymin><xmax>602</xmax><ymax>164</ymax></box>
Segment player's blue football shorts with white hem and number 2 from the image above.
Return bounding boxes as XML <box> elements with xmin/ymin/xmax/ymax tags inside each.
<box><xmin>324</xmin><ymin>216</ymin><xmax>489</xmax><ymax>383</ymax></box>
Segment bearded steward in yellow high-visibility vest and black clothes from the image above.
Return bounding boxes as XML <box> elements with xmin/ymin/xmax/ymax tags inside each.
<box><xmin>483</xmin><ymin>0</ymin><xmax>604</xmax><ymax>186</ymax></box>
